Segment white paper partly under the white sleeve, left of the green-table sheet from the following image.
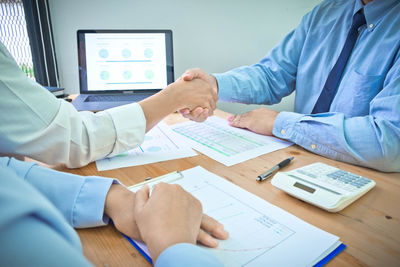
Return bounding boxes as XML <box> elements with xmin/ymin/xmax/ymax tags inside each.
<box><xmin>96</xmin><ymin>122</ymin><xmax>197</xmax><ymax>171</ymax></box>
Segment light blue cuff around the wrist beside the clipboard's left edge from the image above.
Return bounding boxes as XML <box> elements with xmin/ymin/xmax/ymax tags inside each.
<box><xmin>72</xmin><ymin>176</ymin><xmax>119</xmax><ymax>228</ymax></box>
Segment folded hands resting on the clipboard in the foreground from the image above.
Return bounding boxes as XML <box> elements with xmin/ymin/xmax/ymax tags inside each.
<box><xmin>104</xmin><ymin>183</ymin><xmax>228</xmax><ymax>259</ymax></box>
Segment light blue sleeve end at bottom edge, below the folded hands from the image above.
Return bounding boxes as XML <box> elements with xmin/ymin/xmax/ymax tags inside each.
<box><xmin>155</xmin><ymin>243</ymin><xmax>223</xmax><ymax>267</ymax></box>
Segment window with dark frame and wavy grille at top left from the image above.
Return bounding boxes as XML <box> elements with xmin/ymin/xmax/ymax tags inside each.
<box><xmin>0</xmin><ymin>0</ymin><xmax>59</xmax><ymax>87</ymax></box>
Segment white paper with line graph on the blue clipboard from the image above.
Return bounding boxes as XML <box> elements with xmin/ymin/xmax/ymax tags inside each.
<box><xmin>131</xmin><ymin>167</ymin><xmax>341</xmax><ymax>266</ymax></box>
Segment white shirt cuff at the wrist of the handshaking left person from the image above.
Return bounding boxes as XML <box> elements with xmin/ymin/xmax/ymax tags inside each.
<box><xmin>105</xmin><ymin>103</ymin><xmax>146</xmax><ymax>156</ymax></box>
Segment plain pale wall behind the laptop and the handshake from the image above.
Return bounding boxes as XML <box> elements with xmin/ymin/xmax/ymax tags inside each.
<box><xmin>49</xmin><ymin>0</ymin><xmax>320</xmax><ymax>113</ymax></box>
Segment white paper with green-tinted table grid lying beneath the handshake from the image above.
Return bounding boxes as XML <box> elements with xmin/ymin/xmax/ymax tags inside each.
<box><xmin>171</xmin><ymin>116</ymin><xmax>292</xmax><ymax>166</ymax></box>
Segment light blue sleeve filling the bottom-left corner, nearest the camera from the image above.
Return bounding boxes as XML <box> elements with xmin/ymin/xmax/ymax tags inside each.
<box><xmin>0</xmin><ymin>158</ymin><xmax>90</xmax><ymax>266</ymax></box>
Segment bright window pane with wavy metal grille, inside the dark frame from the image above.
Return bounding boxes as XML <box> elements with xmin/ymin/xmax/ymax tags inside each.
<box><xmin>0</xmin><ymin>0</ymin><xmax>35</xmax><ymax>80</ymax></box>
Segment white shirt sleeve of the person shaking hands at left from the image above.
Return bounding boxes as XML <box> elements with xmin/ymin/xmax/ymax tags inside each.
<box><xmin>0</xmin><ymin>43</ymin><xmax>146</xmax><ymax>167</ymax></box>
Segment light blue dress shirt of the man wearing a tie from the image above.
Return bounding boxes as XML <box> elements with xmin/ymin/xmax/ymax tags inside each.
<box><xmin>215</xmin><ymin>0</ymin><xmax>400</xmax><ymax>172</ymax></box>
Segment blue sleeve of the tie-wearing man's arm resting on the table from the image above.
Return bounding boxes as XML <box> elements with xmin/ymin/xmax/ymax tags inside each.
<box><xmin>273</xmin><ymin>53</ymin><xmax>400</xmax><ymax>172</ymax></box>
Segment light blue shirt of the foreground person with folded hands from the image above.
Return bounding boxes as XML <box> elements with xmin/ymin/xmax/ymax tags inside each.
<box><xmin>0</xmin><ymin>157</ymin><xmax>221</xmax><ymax>266</ymax></box>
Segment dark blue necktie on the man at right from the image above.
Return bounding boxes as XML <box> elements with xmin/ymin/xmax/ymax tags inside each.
<box><xmin>312</xmin><ymin>9</ymin><xmax>366</xmax><ymax>114</ymax></box>
